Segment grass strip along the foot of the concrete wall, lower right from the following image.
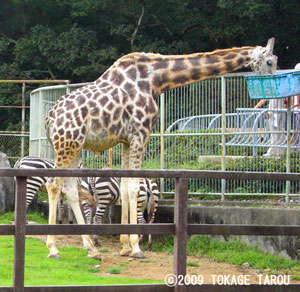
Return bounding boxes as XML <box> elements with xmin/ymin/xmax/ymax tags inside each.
<box><xmin>152</xmin><ymin>235</ymin><xmax>300</xmax><ymax>279</ymax></box>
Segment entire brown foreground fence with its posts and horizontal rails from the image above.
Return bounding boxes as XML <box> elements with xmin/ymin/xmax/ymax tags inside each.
<box><xmin>0</xmin><ymin>168</ymin><xmax>300</xmax><ymax>292</ymax></box>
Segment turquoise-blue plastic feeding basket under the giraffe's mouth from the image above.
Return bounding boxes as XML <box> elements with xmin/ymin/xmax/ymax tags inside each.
<box><xmin>245</xmin><ymin>70</ymin><xmax>300</xmax><ymax>99</ymax></box>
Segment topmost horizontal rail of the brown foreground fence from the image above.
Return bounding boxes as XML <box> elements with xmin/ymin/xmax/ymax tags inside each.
<box><xmin>0</xmin><ymin>168</ymin><xmax>300</xmax><ymax>181</ymax></box>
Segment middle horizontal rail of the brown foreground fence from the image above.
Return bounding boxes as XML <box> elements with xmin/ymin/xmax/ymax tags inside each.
<box><xmin>0</xmin><ymin>223</ymin><xmax>300</xmax><ymax>236</ymax></box>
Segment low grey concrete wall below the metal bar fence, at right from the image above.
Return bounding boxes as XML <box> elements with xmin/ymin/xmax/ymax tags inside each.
<box><xmin>156</xmin><ymin>205</ymin><xmax>300</xmax><ymax>259</ymax></box>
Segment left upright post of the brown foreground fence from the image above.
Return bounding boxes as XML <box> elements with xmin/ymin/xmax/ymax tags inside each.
<box><xmin>13</xmin><ymin>177</ymin><xmax>27</xmax><ymax>292</ymax></box>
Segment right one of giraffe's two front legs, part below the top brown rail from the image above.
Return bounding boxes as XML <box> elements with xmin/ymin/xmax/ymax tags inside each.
<box><xmin>128</xmin><ymin>178</ymin><xmax>146</xmax><ymax>259</ymax></box>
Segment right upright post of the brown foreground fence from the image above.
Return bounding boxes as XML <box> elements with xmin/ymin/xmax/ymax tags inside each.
<box><xmin>174</xmin><ymin>178</ymin><xmax>188</xmax><ymax>292</ymax></box>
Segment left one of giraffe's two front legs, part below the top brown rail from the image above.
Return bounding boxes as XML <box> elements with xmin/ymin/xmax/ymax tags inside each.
<box><xmin>120</xmin><ymin>177</ymin><xmax>131</xmax><ymax>256</ymax></box>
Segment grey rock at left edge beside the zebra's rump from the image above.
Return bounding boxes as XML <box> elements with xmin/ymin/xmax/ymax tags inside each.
<box><xmin>0</xmin><ymin>152</ymin><xmax>15</xmax><ymax>214</ymax></box>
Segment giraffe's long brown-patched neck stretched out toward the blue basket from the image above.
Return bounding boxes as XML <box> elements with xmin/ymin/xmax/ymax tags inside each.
<box><xmin>146</xmin><ymin>47</ymin><xmax>254</xmax><ymax>96</ymax></box>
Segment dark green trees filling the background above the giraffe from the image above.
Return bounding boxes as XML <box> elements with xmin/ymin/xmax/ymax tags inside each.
<box><xmin>0</xmin><ymin>0</ymin><xmax>300</xmax><ymax>130</ymax></box>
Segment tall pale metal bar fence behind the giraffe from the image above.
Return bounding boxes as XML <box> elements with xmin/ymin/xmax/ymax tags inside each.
<box><xmin>30</xmin><ymin>73</ymin><xmax>300</xmax><ymax>200</ymax></box>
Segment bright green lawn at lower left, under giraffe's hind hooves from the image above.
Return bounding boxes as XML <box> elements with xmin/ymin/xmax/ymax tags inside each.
<box><xmin>0</xmin><ymin>236</ymin><xmax>157</xmax><ymax>286</ymax></box>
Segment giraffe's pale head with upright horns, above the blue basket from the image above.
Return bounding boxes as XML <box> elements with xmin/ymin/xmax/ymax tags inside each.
<box><xmin>249</xmin><ymin>38</ymin><xmax>277</xmax><ymax>75</ymax></box>
